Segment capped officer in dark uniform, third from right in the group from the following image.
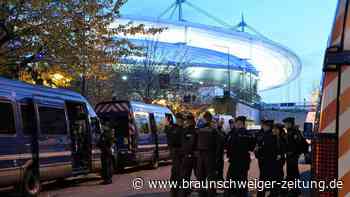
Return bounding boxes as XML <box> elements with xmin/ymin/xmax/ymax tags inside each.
<box><xmin>255</xmin><ymin>120</ymin><xmax>278</xmax><ymax>197</ymax></box>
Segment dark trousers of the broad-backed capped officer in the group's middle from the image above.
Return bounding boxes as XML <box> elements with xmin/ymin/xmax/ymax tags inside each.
<box><xmin>224</xmin><ymin>162</ymin><xmax>250</xmax><ymax>197</ymax></box>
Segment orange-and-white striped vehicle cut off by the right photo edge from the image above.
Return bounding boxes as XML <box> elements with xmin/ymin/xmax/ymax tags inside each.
<box><xmin>312</xmin><ymin>0</ymin><xmax>350</xmax><ymax>197</ymax></box>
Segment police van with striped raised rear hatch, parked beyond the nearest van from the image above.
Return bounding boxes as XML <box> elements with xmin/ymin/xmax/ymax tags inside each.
<box><xmin>95</xmin><ymin>101</ymin><xmax>175</xmax><ymax>170</ymax></box>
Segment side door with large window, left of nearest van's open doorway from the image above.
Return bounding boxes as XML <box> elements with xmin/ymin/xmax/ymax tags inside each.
<box><xmin>34</xmin><ymin>97</ymin><xmax>72</xmax><ymax>180</ymax></box>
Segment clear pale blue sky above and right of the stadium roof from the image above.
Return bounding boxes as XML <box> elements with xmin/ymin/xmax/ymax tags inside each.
<box><xmin>122</xmin><ymin>0</ymin><xmax>337</xmax><ymax>102</ymax></box>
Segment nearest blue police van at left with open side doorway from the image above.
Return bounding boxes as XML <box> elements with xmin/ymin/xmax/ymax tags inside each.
<box><xmin>0</xmin><ymin>78</ymin><xmax>101</xmax><ymax>196</ymax></box>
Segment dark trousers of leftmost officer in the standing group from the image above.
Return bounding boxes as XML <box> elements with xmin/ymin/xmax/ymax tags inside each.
<box><xmin>170</xmin><ymin>153</ymin><xmax>182</xmax><ymax>197</ymax></box>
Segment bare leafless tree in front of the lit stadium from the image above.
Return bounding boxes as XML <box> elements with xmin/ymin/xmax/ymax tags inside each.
<box><xmin>114</xmin><ymin>34</ymin><xmax>192</xmax><ymax>101</ymax></box>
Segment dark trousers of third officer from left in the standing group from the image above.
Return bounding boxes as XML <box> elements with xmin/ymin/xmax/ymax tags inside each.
<box><xmin>196</xmin><ymin>151</ymin><xmax>217</xmax><ymax>197</ymax></box>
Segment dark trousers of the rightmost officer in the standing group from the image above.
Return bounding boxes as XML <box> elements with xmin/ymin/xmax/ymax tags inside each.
<box><xmin>287</xmin><ymin>155</ymin><xmax>300</xmax><ymax>196</ymax></box>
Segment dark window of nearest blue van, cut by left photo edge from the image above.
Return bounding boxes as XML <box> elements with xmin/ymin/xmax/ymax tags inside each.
<box><xmin>0</xmin><ymin>101</ymin><xmax>16</xmax><ymax>134</ymax></box>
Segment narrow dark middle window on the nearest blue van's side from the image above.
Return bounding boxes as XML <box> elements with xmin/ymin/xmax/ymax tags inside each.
<box><xmin>21</xmin><ymin>104</ymin><xmax>36</xmax><ymax>135</ymax></box>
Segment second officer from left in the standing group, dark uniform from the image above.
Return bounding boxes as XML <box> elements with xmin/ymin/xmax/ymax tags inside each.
<box><xmin>180</xmin><ymin>112</ymin><xmax>197</xmax><ymax>197</ymax></box>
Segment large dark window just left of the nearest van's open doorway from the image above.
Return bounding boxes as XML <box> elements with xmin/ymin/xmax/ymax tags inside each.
<box><xmin>39</xmin><ymin>107</ymin><xmax>67</xmax><ymax>135</ymax></box>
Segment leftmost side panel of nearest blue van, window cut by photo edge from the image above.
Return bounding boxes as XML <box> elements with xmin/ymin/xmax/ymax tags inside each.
<box><xmin>0</xmin><ymin>97</ymin><xmax>21</xmax><ymax>186</ymax></box>
